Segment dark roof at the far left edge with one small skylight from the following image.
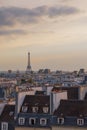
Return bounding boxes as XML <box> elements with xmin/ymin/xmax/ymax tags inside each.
<box><xmin>0</xmin><ymin>105</ymin><xmax>15</xmax><ymax>122</ymax></box>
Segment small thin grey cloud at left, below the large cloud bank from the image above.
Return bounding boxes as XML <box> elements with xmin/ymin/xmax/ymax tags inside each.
<box><xmin>0</xmin><ymin>30</ymin><xmax>27</xmax><ymax>36</ymax></box>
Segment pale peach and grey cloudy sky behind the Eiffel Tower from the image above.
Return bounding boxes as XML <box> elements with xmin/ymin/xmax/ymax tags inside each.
<box><xmin>0</xmin><ymin>0</ymin><xmax>87</xmax><ymax>71</ymax></box>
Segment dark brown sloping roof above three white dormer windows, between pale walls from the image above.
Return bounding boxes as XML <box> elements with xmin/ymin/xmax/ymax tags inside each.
<box><xmin>21</xmin><ymin>95</ymin><xmax>50</xmax><ymax>113</ymax></box>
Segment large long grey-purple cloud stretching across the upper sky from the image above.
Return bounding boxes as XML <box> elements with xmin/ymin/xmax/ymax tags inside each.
<box><xmin>0</xmin><ymin>6</ymin><xmax>79</xmax><ymax>27</ymax></box>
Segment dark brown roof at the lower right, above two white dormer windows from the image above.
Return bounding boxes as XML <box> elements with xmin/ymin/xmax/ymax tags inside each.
<box><xmin>54</xmin><ymin>100</ymin><xmax>87</xmax><ymax>117</ymax></box>
